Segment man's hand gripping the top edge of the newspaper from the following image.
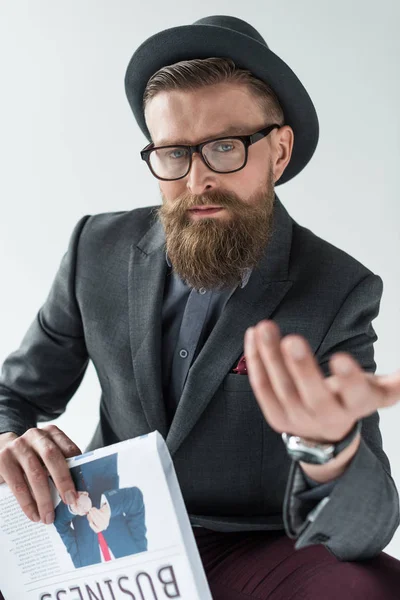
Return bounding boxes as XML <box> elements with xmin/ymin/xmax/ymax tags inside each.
<box><xmin>0</xmin><ymin>425</ymin><xmax>82</xmax><ymax>525</ymax></box>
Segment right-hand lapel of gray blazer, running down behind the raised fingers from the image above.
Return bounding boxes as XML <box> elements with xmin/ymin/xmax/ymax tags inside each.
<box><xmin>166</xmin><ymin>196</ymin><xmax>293</xmax><ymax>454</ymax></box>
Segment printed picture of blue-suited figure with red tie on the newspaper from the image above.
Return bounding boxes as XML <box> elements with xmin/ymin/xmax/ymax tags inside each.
<box><xmin>54</xmin><ymin>454</ymin><xmax>147</xmax><ymax>568</ymax></box>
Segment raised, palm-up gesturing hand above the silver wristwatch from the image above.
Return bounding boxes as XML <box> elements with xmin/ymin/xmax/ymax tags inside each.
<box><xmin>244</xmin><ymin>321</ymin><xmax>400</xmax><ymax>443</ymax></box>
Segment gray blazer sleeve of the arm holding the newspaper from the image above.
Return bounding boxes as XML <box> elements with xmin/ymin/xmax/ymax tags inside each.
<box><xmin>0</xmin><ymin>215</ymin><xmax>90</xmax><ymax>435</ymax></box>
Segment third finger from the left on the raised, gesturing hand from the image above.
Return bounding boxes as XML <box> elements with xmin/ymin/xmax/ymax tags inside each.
<box><xmin>281</xmin><ymin>335</ymin><xmax>343</xmax><ymax>419</ymax></box>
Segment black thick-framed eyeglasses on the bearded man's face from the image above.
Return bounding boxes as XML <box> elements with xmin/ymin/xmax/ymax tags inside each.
<box><xmin>140</xmin><ymin>124</ymin><xmax>281</xmax><ymax>181</ymax></box>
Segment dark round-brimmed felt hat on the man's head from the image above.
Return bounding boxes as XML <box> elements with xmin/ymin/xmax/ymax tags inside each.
<box><xmin>125</xmin><ymin>15</ymin><xmax>319</xmax><ymax>185</ymax></box>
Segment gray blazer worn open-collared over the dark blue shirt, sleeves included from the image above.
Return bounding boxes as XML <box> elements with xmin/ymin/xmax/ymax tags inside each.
<box><xmin>0</xmin><ymin>197</ymin><xmax>399</xmax><ymax>560</ymax></box>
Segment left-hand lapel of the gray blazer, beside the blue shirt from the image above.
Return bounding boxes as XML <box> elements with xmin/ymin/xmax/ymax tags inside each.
<box><xmin>128</xmin><ymin>214</ymin><xmax>168</xmax><ymax>438</ymax></box>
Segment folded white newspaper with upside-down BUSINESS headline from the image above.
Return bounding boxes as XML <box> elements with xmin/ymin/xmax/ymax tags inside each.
<box><xmin>0</xmin><ymin>431</ymin><xmax>212</xmax><ymax>600</ymax></box>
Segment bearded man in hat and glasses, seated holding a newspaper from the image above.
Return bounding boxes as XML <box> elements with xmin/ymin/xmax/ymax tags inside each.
<box><xmin>0</xmin><ymin>16</ymin><xmax>400</xmax><ymax>600</ymax></box>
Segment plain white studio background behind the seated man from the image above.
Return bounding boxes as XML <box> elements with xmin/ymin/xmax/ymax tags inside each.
<box><xmin>0</xmin><ymin>0</ymin><xmax>400</xmax><ymax>558</ymax></box>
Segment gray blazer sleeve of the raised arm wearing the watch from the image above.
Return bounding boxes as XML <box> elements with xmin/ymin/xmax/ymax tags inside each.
<box><xmin>283</xmin><ymin>273</ymin><xmax>399</xmax><ymax>561</ymax></box>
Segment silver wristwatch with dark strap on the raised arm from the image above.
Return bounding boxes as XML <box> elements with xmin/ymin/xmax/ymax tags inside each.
<box><xmin>282</xmin><ymin>421</ymin><xmax>361</xmax><ymax>465</ymax></box>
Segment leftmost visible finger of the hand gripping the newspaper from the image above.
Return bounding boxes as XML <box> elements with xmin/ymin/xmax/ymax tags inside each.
<box><xmin>0</xmin><ymin>447</ymin><xmax>40</xmax><ymax>522</ymax></box>
